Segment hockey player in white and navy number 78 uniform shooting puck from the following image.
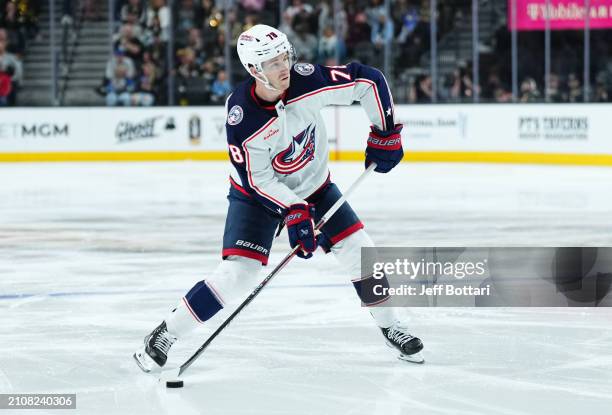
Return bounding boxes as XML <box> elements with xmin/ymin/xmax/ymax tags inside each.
<box><xmin>134</xmin><ymin>25</ymin><xmax>423</xmax><ymax>372</ymax></box>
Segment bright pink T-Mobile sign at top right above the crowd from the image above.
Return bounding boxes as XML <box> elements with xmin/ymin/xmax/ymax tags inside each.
<box><xmin>508</xmin><ymin>0</ymin><xmax>612</xmax><ymax>30</ymax></box>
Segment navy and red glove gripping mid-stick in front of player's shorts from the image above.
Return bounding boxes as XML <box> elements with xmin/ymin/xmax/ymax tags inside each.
<box><xmin>285</xmin><ymin>203</ymin><xmax>317</xmax><ymax>259</ymax></box>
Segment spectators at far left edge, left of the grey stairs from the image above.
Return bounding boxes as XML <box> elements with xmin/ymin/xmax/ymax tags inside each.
<box><xmin>0</xmin><ymin>0</ymin><xmax>39</xmax><ymax>107</ymax></box>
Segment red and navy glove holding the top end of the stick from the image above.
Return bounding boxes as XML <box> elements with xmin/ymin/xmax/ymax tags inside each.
<box><xmin>366</xmin><ymin>124</ymin><xmax>404</xmax><ymax>173</ymax></box>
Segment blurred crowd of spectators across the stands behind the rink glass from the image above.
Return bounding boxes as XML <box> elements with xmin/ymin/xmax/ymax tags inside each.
<box><xmin>0</xmin><ymin>0</ymin><xmax>612</xmax><ymax>106</ymax></box>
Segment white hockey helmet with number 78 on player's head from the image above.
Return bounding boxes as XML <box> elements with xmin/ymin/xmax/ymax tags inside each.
<box><xmin>236</xmin><ymin>24</ymin><xmax>296</xmax><ymax>90</ymax></box>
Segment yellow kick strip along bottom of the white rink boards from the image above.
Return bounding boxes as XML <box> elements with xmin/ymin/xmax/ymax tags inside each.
<box><xmin>0</xmin><ymin>151</ymin><xmax>612</xmax><ymax>166</ymax></box>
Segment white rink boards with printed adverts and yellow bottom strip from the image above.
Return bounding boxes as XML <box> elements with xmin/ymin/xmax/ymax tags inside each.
<box><xmin>0</xmin><ymin>104</ymin><xmax>612</xmax><ymax>165</ymax></box>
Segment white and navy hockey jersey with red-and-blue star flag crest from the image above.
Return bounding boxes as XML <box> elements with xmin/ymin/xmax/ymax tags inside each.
<box><xmin>226</xmin><ymin>63</ymin><xmax>395</xmax><ymax>215</ymax></box>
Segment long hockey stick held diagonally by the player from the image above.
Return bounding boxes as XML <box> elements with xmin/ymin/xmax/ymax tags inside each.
<box><xmin>178</xmin><ymin>163</ymin><xmax>376</xmax><ymax>376</ymax></box>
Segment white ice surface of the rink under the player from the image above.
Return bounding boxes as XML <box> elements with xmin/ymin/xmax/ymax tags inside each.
<box><xmin>0</xmin><ymin>163</ymin><xmax>612</xmax><ymax>415</ymax></box>
